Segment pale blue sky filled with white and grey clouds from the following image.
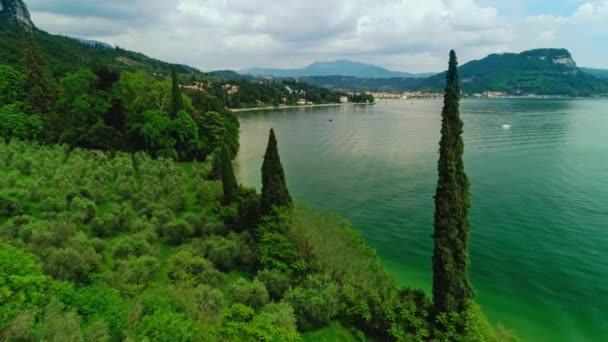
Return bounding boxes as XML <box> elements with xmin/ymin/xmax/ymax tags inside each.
<box><xmin>25</xmin><ymin>0</ymin><xmax>608</xmax><ymax>72</ymax></box>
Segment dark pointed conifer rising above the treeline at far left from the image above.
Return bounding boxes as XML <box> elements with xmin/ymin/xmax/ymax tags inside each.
<box><xmin>25</xmin><ymin>39</ymin><xmax>53</xmax><ymax>113</ymax></box>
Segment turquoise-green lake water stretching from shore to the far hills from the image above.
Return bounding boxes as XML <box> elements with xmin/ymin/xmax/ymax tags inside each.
<box><xmin>237</xmin><ymin>100</ymin><xmax>608</xmax><ymax>341</ymax></box>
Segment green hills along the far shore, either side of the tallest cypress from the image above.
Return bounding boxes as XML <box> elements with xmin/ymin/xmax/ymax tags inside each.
<box><xmin>301</xmin><ymin>49</ymin><xmax>608</xmax><ymax>96</ymax></box>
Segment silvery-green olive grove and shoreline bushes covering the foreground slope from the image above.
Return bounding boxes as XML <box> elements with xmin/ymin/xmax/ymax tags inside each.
<box><xmin>0</xmin><ymin>138</ymin><xmax>514</xmax><ymax>341</ymax></box>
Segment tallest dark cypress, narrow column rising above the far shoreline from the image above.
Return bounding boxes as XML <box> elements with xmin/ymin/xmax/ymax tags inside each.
<box><xmin>433</xmin><ymin>50</ymin><xmax>475</xmax><ymax>313</ymax></box>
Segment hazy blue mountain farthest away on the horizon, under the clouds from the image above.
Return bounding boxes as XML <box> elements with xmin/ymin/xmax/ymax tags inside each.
<box><xmin>240</xmin><ymin>60</ymin><xmax>433</xmax><ymax>78</ymax></box>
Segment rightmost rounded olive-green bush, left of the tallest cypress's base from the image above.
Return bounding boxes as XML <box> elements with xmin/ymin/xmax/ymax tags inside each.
<box><xmin>284</xmin><ymin>275</ymin><xmax>339</xmax><ymax>331</ymax></box>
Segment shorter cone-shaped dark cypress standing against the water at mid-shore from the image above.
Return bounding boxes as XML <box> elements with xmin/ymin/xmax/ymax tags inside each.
<box><xmin>260</xmin><ymin>129</ymin><xmax>292</xmax><ymax>215</ymax></box>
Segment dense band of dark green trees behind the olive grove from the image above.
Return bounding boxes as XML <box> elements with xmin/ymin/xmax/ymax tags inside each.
<box><xmin>0</xmin><ymin>42</ymin><xmax>239</xmax><ymax>161</ymax></box>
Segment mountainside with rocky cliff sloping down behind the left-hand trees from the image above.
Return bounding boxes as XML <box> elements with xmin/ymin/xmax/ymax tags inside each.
<box><xmin>0</xmin><ymin>0</ymin><xmax>203</xmax><ymax>76</ymax></box>
